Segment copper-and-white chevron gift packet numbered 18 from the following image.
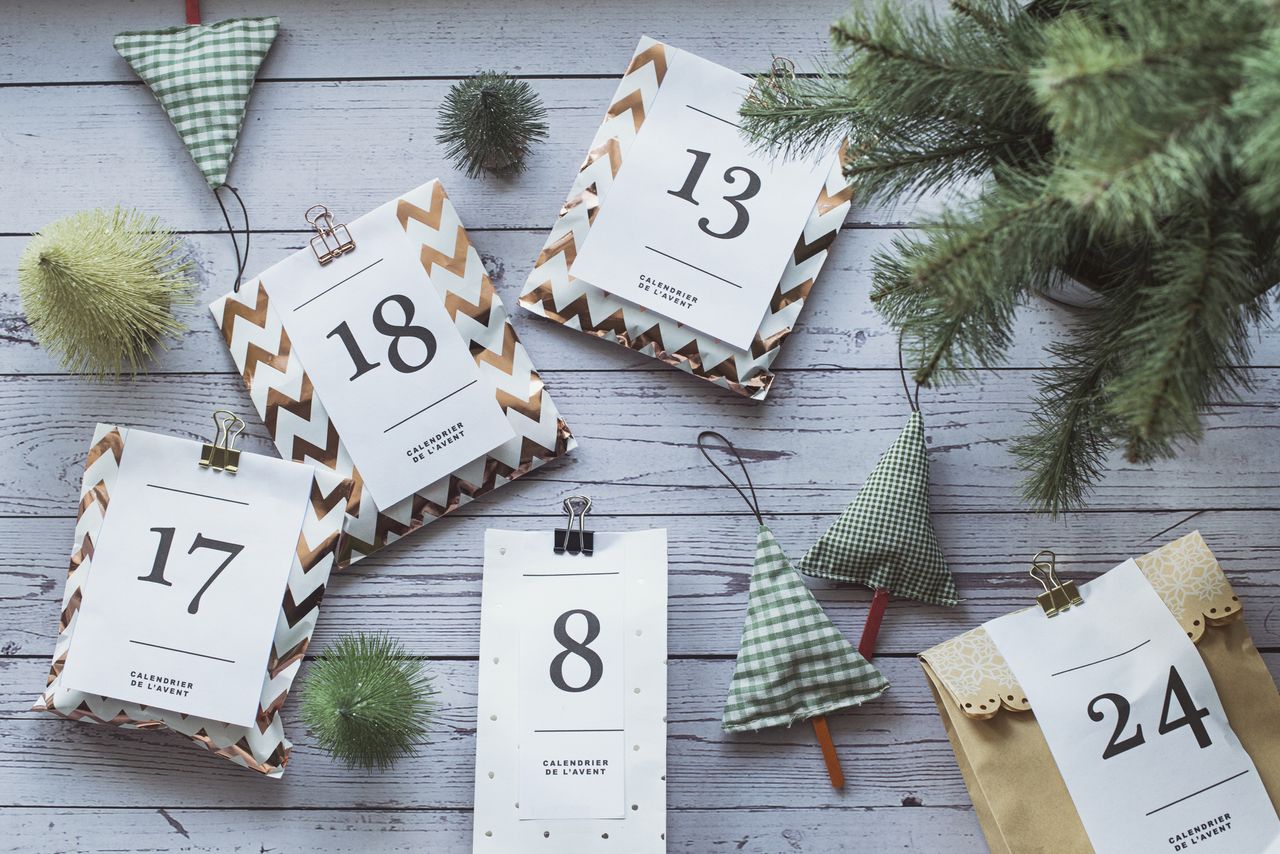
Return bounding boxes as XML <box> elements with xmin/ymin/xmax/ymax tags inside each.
<box><xmin>210</xmin><ymin>181</ymin><xmax>576</xmax><ymax>563</ymax></box>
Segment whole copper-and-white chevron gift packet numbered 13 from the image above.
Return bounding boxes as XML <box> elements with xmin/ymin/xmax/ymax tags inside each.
<box><xmin>520</xmin><ymin>38</ymin><xmax>851</xmax><ymax>398</ymax></box>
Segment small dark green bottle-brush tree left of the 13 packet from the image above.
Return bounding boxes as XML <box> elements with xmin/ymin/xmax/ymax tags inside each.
<box><xmin>435</xmin><ymin>72</ymin><xmax>547</xmax><ymax>178</ymax></box>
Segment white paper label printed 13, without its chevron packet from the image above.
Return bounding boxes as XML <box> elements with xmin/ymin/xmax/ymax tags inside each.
<box><xmin>573</xmin><ymin>50</ymin><xmax>836</xmax><ymax>350</ymax></box>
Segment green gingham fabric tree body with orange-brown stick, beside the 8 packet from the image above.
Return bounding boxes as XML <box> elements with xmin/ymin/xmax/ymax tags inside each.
<box><xmin>723</xmin><ymin>525</ymin><xmax>888</xmax><ymax>732</ymax></box>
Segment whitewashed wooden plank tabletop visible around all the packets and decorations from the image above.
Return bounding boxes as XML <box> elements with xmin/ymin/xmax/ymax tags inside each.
<box><xmin>0</xmin><ymin>0</ymin><xmax>1280</xmax><ymax>854</ymax></box>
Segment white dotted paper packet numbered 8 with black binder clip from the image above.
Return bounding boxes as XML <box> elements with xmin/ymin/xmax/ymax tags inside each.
<box><xmin>472</xmin><ymin>530</ymin><xmax>667</xmax><ymax>854</ymax></box>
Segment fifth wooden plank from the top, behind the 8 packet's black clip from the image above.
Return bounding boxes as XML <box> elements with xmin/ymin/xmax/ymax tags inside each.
<box><xmin>0</xmin><ymin>512</ymin><xmax>1280</xmax><ymax>657</ymax></box>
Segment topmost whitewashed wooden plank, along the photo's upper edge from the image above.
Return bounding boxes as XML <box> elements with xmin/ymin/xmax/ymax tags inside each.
<box><xmin>0</xmin><ymin>0</ymin><xmax>870</xmax><ymax>83</ymax></box>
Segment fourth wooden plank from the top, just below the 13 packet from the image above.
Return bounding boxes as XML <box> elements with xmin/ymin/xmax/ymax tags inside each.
<box><xmin>0</xmin><ymin>366</ymin><xmax>1280</xmax><ymax>514</ymax></box>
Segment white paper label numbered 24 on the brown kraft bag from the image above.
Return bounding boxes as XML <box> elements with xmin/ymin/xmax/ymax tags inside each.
<box><xmin>984</xmin><ymin>561</ymin><xmax>1280</xmax><ymax>854</ymax></box>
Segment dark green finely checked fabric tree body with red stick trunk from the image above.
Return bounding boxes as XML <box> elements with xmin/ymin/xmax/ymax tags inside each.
<box><xmin>797</xmin><ymin>412</ymin><xmax>956</xmax><ymax>606</ymax></box>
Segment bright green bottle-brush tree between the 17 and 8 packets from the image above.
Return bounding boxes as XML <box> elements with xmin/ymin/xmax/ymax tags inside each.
<box><xmin>302</xmin><ymin>632</ymin><xmax>436</xmax><ymax>769</ymax></box>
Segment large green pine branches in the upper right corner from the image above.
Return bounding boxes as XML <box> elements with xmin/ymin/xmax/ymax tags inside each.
<box><xmin>742</xmin><ymin>0</ymin><xmax>1280</xmax><ymax>513</ymax></box>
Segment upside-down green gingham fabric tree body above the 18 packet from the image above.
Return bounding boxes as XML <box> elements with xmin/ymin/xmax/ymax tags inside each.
<box><xmin>115</xmin><ymin>18</ymin><xmax>280</xmax><ymax>189</ymax></box>
